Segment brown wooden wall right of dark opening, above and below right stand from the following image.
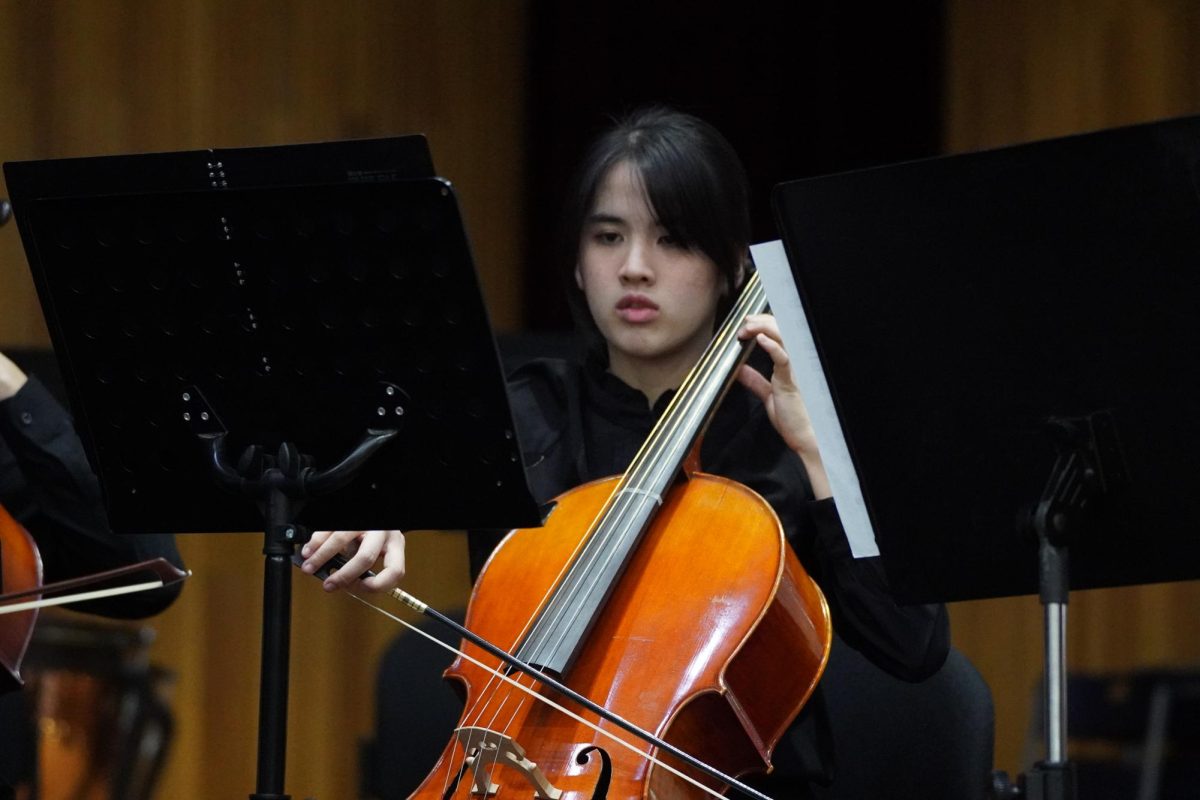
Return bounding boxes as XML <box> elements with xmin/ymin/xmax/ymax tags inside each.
<box><xmin>946</xmin><ymin>0</ymin><xmax>1200</xmax><ymax>771</ymax></box>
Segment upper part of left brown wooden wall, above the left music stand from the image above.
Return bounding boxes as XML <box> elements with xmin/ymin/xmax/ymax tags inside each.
<box><xmin>0</xmin><ymin>0</ymin><xmax>524</xmax><ymax>345</ymax></box>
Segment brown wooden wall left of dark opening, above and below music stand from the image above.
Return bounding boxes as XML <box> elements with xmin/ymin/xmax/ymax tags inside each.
<box><xmin>0</xmin><ymin>0</ymin><xmax>527</xmax><ymax>798</ymax></box>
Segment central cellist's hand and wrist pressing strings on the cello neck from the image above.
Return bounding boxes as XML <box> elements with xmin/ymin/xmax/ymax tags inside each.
<box><xmin>738</xmin><ymin>314</ymin><xmax>832</xmax><ymax>500</ymax></box>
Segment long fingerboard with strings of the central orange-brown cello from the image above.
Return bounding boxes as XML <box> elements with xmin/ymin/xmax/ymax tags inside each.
<box><xmin>517</xmin><ymin>272</ymin><xmax>767</xmax><ymax>674</ymax></box>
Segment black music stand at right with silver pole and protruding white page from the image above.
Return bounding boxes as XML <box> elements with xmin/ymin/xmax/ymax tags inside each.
<box><xmin>774</xmin><ymin>118</ymin><xmax>1200</xmax><ymax>798</ymax></box>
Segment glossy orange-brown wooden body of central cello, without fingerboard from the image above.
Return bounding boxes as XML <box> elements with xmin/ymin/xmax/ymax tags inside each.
<box><xmin>413</xmin><ymin>474</ymin><xmax>830</xmax><ymax>800</ymax></box>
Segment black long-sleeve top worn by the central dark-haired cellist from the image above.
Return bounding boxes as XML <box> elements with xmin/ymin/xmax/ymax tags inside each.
<box><xmin>470</xmin><ymin>360</ymin><xmax>949</xmax><ymax>782</ymax></box>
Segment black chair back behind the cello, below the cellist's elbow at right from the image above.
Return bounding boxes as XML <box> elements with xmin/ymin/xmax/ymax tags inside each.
<box><xmin>815</xmin><ymin>637</ymin><xmax>995</xmax><ymax>800</ymax></box>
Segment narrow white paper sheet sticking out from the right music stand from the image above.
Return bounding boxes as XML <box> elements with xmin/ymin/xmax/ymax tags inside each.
<box><xmin>750</xmin><ymin>239</ymin><xmax>880</xmax><ymax>558</ymax></box>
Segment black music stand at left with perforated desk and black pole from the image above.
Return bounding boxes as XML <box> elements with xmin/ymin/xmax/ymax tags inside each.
<box><xmin>5</xmin><ymin>137</ymin><xmax>540</xmax><ymax>800</ymax></box>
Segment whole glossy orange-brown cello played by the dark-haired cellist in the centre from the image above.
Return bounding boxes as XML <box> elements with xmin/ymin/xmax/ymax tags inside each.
<box><xmin>412</xmin><ymin>273</ymin><xmax>832</xmax><ymax>800</ymax></box>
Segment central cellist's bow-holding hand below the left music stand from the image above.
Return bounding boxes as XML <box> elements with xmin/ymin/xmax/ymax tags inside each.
<box><xmin>300</xmin><ymin>530</ymin><xmax>404</xmax><ymax>591</ymax></box>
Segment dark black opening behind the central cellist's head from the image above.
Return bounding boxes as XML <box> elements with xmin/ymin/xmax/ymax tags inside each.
<box><xmin>524</xmin><ymin>0</ymin><xmax>943</xmax><ymax>330</ymax></box>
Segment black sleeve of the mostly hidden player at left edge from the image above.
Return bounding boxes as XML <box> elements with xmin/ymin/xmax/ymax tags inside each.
<box><xmin>0</xmin><ymin>377</ymin><xmax>182</xmax><ymax>619</ymax></box>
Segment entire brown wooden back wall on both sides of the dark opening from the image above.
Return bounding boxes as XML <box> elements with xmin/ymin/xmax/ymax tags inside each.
<box><xmin>9</xmin><ymin>0</ymin><xmax>1200</xmax><ymax>796</ymax></box>
